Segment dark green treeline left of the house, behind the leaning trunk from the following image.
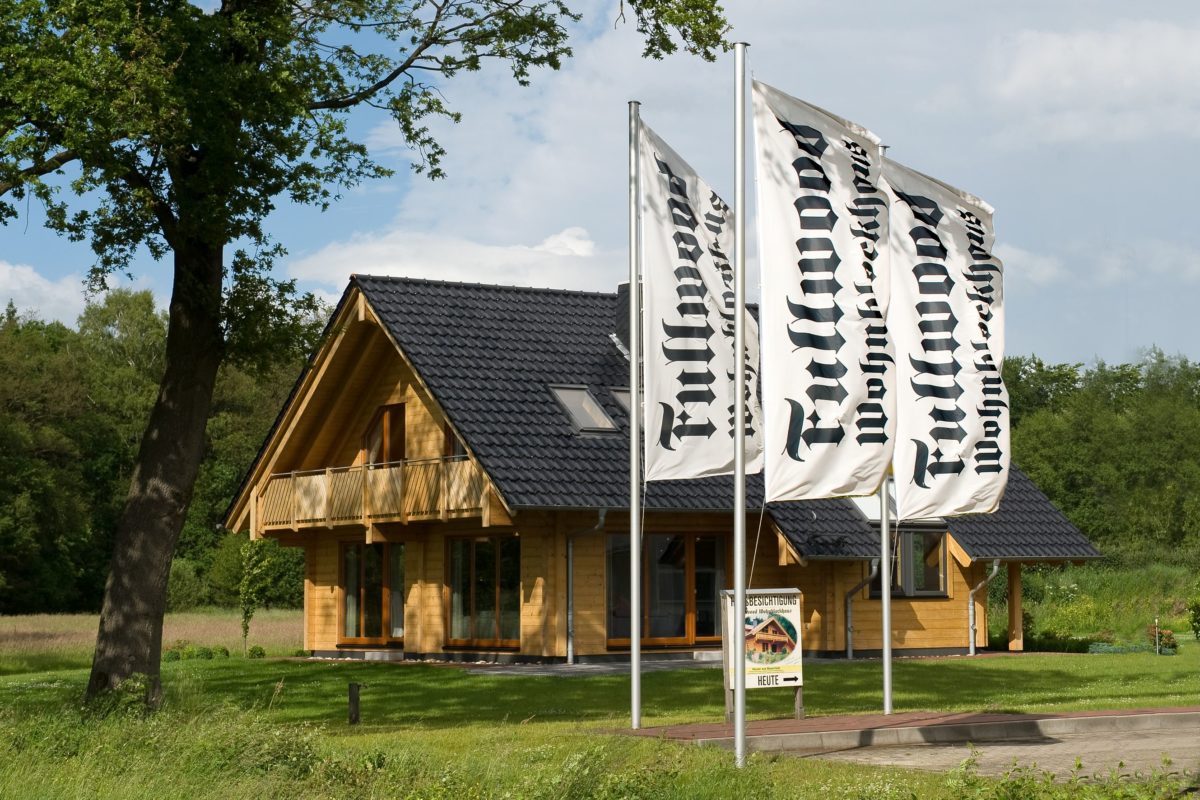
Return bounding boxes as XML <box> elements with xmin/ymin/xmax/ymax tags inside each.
<box><xmin>0</xmin><ymin>289</ymin><xmax>318</xmax><ymax>614</ymax></box>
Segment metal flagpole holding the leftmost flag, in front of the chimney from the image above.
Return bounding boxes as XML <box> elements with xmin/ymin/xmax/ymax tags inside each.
<box><xmin>629</xmin><ymin>100</ymin><xmax>642</xmax><ymax>730</ymax></box>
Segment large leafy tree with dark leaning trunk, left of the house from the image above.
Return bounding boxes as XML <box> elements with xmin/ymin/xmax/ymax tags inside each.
<box><xmin>0</xmin><ymin>0</ymin><xmax>727</xmax><ymax>705</ymax></box>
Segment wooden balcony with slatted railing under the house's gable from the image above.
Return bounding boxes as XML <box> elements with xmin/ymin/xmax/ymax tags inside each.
<box><xmin>257</xmin><ymin>456</ymin><xmax>484</xmax><ymax>530</ymax></box>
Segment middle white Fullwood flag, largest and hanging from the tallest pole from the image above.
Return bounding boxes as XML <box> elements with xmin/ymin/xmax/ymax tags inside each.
<box><xmin>754</xmin><ymin>82</ymin><xmax>895</xmax><ymax>500</ymax></box>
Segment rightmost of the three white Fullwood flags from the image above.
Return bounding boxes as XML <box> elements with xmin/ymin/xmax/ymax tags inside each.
<box><xmin>883</xmin><ymin>160</ymin><xmax>1009</xmax><ymax>519</ymax></box>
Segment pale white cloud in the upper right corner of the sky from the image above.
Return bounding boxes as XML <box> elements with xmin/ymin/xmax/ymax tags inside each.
<box><xmin>990</xmin><ymin>20</ymin><xmax>1200</xmax><ymax>143</ymax></box>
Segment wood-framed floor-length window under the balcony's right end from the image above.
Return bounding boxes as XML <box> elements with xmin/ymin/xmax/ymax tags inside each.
<box><xmin>446</xmin><ymin>536</ymin><xmax>521</xmax><ymax>648</ymax></box>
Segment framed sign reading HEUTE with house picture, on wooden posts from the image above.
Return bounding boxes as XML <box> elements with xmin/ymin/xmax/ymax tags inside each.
<box><xmin>721</xmin><ymin>589</ymin><xmax>804</xmax><ymax>722</ymax></box>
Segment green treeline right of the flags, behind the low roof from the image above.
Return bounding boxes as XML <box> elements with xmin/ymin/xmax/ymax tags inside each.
<box><xmin>1004</xmin><ymin>348</ymin><xmax>1200</xmax><ymax>565</ymax></box>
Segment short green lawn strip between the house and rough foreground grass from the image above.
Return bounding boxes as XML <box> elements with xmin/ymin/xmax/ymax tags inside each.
<box><xmin>0</xmin><ymin>655</ymin><xmax>1200</xmax><ymax>730</ymax></box>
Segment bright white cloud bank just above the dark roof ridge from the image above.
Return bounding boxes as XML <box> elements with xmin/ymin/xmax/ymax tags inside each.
<box><xmin>288</xmin><ymin>228</ymin><xmax>624</xmax><ymax>291</ymax></box>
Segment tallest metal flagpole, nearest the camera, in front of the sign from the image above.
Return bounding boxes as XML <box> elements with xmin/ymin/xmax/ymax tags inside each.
<box><xmin>730</xmin><ymin>42</ymin><xmax>746</xmax><ymax>766</ymax></box>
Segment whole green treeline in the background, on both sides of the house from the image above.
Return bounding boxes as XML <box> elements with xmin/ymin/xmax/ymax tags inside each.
<box><xmin>0</xmin><ymin>290</ymin><xmax>1200</xmax><ymax>614</ymax></box>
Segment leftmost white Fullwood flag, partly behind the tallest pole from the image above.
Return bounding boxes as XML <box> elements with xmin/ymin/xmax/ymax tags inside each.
<box><xmin>638</xmin><ymin>125</ymin><xmax>762</xmax><ymax>481</ymax></box>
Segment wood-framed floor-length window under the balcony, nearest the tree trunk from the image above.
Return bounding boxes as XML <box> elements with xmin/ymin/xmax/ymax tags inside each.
<box><xmin>338</xmin><ymin>542</ymin><xmax>404</xmax><ymax>644</ymax></box>
